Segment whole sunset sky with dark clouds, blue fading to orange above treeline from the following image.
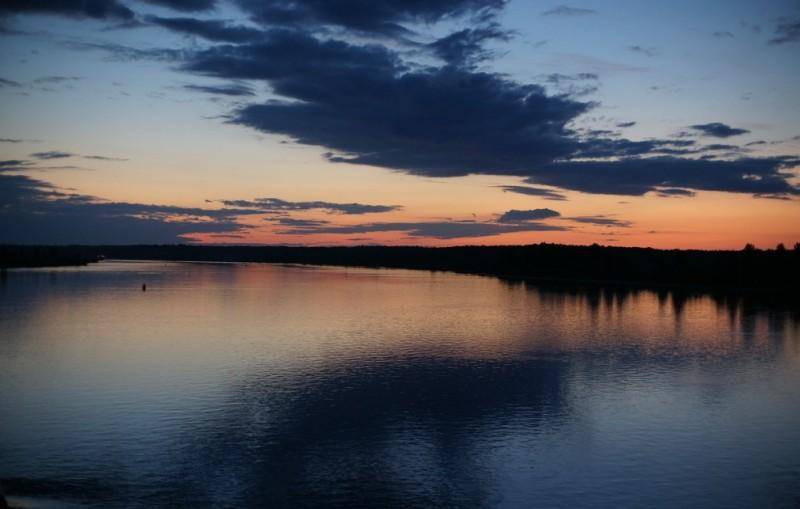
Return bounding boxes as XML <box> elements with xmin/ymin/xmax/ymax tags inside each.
<box><xmin>0</xmin><ymin>0</ymin><xmax>800</xmax><ymax>249</ymax></box>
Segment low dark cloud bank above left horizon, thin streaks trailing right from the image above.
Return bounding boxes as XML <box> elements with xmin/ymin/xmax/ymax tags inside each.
<box><xmin>0</xmin><ymin>172</ymin><xmax>422</xmax><ymax>244</ymax></box>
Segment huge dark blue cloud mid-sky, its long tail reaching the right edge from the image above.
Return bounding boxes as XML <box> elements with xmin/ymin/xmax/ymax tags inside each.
<box><xmin>185</xmin><ymin>30</ymin><xmax>796</xmax><ymax>195</ymax></box>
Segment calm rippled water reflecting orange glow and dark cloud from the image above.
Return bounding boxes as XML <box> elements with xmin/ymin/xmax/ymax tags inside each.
<box><xmin>0</xmin><ymin>262</ymin><xmax>800</xmax><ymax>508</ymax></box>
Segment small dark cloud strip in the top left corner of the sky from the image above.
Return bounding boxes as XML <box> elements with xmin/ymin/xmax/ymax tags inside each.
<box><xmin>0</xmin><ymin>0</ymin><xmax>135</xmax><ymax>21</ymax></box>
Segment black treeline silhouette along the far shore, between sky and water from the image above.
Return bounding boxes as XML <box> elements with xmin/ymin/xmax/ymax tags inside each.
<box><xmin>0</xmin><ymin>244</ymin><xmax>800</xmax><ymax>292</ymax></box>
